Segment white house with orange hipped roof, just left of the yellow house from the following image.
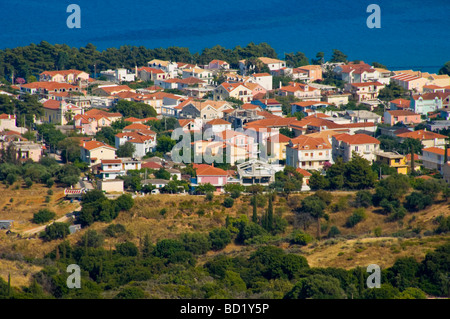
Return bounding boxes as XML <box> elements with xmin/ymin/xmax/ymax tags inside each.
<box><xmin>332</xmin><ymin>133</ymin><xmax>380</xmax><ymax>163</ymax></box>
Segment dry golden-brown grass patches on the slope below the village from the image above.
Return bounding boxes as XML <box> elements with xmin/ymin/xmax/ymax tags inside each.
<box><xmin>0</xmin><ymin>190</ymin><xmax>450</xmax><ymax>285</ymax></box>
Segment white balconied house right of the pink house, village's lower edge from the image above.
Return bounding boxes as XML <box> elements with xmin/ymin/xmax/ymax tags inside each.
<box><xmin>237</xmin><ymin>159</ymin><xmax>276</xmax><ymax>186</ymax></box>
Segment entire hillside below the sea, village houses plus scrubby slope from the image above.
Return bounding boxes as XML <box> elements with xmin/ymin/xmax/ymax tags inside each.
<box><xmin>0</xmin><ymin>46</ymin><xmax>450</xmax><ymax>299</ymax></box>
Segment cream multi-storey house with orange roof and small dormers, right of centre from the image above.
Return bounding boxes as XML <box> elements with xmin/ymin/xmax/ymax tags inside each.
<box><xmin>286</xmin><ymin>135</ymin><xmax>333</xmax><ymax>170</ymax></box>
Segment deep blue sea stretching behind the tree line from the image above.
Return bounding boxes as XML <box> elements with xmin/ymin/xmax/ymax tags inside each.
<box><xmin>0</xmin><ymin>0</ymin><xmax>450</xmax><ymax>72</ymax></box>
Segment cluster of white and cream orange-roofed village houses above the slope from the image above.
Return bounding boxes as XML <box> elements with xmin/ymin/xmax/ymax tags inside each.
<box><xmin>0</xmin><ymin>57</ymin><xmax>450</xmax><ymax>193</ymax></box>
